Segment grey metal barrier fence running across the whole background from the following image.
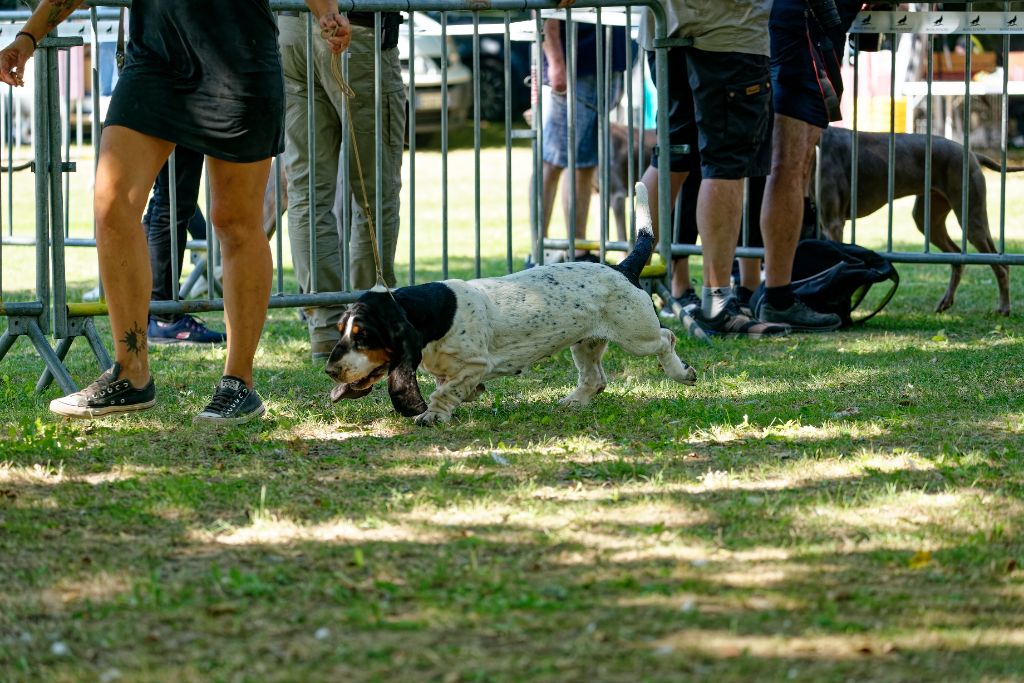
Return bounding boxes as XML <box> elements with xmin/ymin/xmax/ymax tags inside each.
<box><xmin>0</xmin><ymin>0</ymin><xmax>1024</xmax><ymax>391</ymax></box>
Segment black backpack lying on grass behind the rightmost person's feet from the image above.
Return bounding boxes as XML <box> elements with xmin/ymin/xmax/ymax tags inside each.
<box><xmin>751</xmin><ymin>240</ymin><xmax>899</xmax><ymax>327</ymax></box>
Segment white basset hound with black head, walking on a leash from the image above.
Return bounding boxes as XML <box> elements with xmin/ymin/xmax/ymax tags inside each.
<box><xmin>326</xmin><ymin>183</ymin><xmax>696</xmax><ymax>425</ymax></box>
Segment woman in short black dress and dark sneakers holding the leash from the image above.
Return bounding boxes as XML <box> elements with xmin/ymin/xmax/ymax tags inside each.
<box><xmin>0</xmin><ymin>0</ymin><xmax>350</xmax><ymax>424</ymax></box>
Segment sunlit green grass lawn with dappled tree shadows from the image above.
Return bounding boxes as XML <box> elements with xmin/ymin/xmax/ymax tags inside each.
<box><xmin>0</xmin><ymin>131</ymin><xmax>1024</xmax><ymax>683</ymax></box>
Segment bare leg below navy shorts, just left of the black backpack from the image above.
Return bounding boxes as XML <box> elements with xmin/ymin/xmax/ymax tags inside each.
<box><xmin>761</xmin><ymin>114</ymin><xmax>821</xmax><ymax>287</ymax></box>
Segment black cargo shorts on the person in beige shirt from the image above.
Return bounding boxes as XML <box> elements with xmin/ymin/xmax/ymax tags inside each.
<box><xmin>647</xmin><ymin>47</ymin><xmax>772</xmax><ymax>179</ymax></box>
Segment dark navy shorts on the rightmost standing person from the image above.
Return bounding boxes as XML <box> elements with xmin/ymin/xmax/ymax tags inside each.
<box><xmin>768</xmin><ymin>0</ymin><xmax>861</xmax><ymax>128</ymax></box>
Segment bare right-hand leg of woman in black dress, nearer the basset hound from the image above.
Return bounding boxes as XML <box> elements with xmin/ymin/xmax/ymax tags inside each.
<box><xmin>207</xmin><ymin>157</ymin><xmax>273</xmax><ymax>387</ymax></box>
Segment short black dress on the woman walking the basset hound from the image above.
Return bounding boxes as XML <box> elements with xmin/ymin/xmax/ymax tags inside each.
<box><xmin>104</xmin><ymin>0</ymin><xmax>285</xmax><ymax>163</ymax></box>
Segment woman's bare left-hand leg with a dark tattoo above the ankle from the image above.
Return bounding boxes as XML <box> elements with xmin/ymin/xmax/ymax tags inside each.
<box><xmin>94</xmin><ymin>126</ymin><xmax>175</xmax><ymax>387</ymax></box>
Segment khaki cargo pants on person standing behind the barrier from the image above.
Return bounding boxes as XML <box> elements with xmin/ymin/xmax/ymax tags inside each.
<box><xmin>279</xmin><ymin>16</ymin><xmax>406</xmax><ymax>341</ymax></box>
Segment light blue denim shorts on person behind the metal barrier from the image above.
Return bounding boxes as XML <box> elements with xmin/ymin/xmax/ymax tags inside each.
<box><xmin>544</xmin><ymin>75</ymin><xmax>597</xmax><ymax>168</ymax></box>
